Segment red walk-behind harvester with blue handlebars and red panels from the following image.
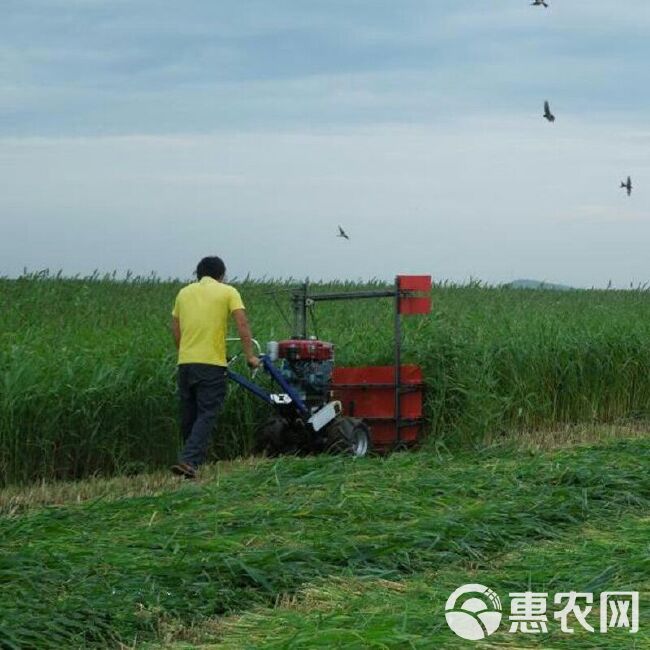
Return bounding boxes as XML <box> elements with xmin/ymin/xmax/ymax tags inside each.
<box><xmin>228</xmin><ymin>275</ymin><xmax>431</xmax><ymax>456</ymax></box>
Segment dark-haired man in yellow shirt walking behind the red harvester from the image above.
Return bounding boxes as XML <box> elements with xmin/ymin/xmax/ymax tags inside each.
<box><xmin>172</xmin><ymin>257</ymin><xmax>260</xmax><ymax>478</ymax></box>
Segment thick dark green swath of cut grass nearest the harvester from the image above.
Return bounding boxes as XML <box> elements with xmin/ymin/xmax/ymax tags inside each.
<box><xmin>0</xmin><ymin>438</ymin><xmax>650</xmax><ymax>648</ymax></box>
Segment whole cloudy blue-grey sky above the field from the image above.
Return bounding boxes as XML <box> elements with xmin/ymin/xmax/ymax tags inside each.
<box><xmin>0</xmin><ymin>0</ymin><xmax>650</xmax><ymax>288</ymax></box>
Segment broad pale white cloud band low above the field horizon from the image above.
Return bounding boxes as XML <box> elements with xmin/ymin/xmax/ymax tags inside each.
<box><xmin>0</xmin><ymin>116</ymin><xmax>650</xmax><ymax>286</ymax></box>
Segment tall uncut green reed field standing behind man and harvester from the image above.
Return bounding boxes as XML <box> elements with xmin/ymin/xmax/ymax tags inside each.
<box><xmin>0</xmin><ymin>274</ymin><xmax>650</xmax><ymax>484</ymax></box>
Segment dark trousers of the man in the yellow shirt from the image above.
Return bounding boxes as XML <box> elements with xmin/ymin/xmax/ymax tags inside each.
<box><xmin>178</xmin><ymin>363</ymin><xmax>227</xmax><ymax>467</ymax></box>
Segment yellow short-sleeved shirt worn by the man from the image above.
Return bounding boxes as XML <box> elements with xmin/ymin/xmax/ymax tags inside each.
<box><xmin>172</xmin><ymin>276</ymin><xmax>244</xmax><ymax>366</ymax></box>
